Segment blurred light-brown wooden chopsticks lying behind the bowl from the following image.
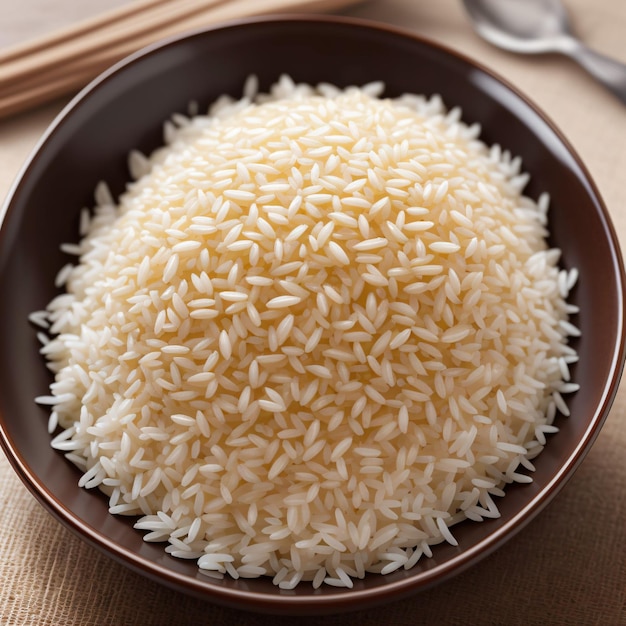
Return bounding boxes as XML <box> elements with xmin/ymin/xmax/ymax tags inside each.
<box><xmin>0</xmin><ymin>0</ymin><xmax>358</xmax><ymax>118</ymax></box>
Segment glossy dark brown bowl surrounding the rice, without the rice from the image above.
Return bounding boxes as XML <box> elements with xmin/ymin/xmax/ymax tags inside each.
<box><xmin>0</xmin><ymin>17</ymin><xmax>624</xmax><ymax>614</ymax></box>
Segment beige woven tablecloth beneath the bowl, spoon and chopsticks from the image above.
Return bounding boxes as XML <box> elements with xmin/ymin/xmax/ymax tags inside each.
<box><xmin>0</xmin><ymin>0</ymin><xmax>626</xmax><ymax>626</ymax></box>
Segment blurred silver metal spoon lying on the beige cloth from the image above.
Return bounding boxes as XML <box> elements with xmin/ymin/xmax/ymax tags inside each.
<box><xmin>463</xmin><ymin>0</ymin><xmax>626</xmax><ymax>104</ymax></box>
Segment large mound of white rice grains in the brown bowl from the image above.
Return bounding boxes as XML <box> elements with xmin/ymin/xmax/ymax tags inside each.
<box><xmin>33</xmin><ymin>77</ymin><xmax>578</xmax><ymax>589</ymax></box>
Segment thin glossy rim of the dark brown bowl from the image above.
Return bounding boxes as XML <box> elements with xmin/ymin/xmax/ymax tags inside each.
<box><xmin>0</xmin><ymin>13</ymin><xmax>626</xmax><ymax>614</ymax></box>
